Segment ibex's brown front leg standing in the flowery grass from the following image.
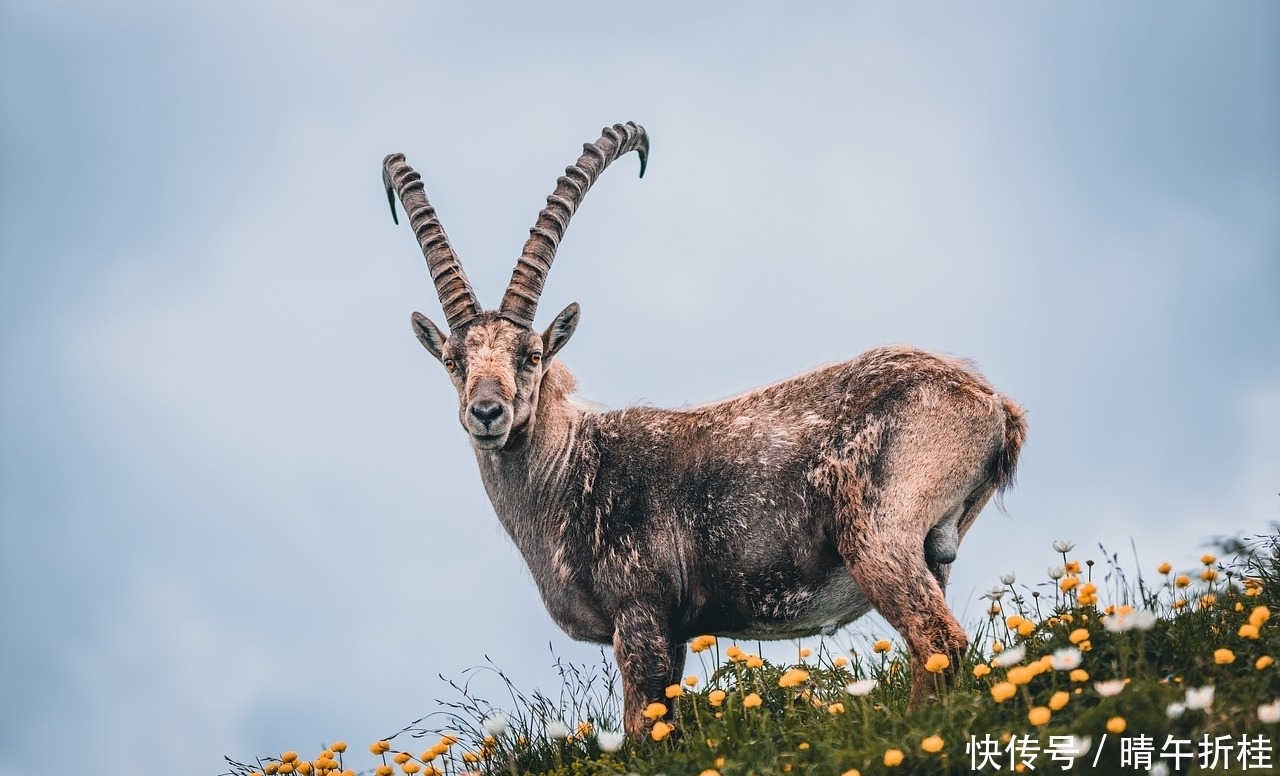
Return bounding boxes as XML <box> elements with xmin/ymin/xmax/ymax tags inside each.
<box><xmin>613</xmin><ymin>608</ymin><xmax>685</xmax><ymax>739</ymax></box>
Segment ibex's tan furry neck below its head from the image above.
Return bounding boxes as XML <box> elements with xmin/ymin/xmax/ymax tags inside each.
<box><xmin>476</xmin><ymin>359</ymin><xmax>582</xmax><ymax>540</ymax></box>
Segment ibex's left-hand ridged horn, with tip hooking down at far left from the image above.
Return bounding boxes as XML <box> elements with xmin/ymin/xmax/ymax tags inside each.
<box><xmin>383</xmin><ymin>154</ymin><xmax>481</xmax><ymax>330</ymax></box>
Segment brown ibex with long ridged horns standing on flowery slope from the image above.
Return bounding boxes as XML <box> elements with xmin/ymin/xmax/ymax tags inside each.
<box><xmin>383</xmin><ymin>123</ymin><xmax>1027</xmax><ymax>735</ymax></box>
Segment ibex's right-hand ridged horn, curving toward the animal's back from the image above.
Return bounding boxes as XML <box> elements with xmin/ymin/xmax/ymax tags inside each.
<box><xmin>498</xmin><ymin>122</ymin><xmax>649</xmax><ymax>328</ymax></box>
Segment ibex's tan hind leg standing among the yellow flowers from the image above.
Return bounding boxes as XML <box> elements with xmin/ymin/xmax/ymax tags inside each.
<box><xmin>840</xmin><ymin>505</ymin><xmax>969</xmax><ymax>708</ymax></box>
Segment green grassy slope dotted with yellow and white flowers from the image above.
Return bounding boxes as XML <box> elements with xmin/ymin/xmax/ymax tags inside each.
<box><xmin>229</xmin><ymin>535</ymin><xmax>1280</xmax><ymax>776</ymax></box>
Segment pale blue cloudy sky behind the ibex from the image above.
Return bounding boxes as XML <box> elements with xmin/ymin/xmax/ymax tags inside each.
<box><xmin>0</xmin><ymin>0</ymin><xmax>1280</xmax><ymax>776</ymax></box>
